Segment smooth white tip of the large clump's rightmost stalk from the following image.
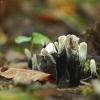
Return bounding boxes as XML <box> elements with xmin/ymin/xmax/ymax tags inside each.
<box><xmin>79</xmin><ymin>42</ymin><xmax>87</xmax><ymax>61</ymax></box>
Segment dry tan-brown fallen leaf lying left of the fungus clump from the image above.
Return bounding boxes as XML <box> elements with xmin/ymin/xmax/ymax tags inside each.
<box><xmin>0</xmin><ymin>68</ymin><xmax>55</xmax><ymax>82</ymax></box>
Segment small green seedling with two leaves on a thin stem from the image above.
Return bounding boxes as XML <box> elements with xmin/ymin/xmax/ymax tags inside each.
<box><xmin>15</xmin><ymin>32</ymin><xmax>50</xmax><ymax>52</ymax></box>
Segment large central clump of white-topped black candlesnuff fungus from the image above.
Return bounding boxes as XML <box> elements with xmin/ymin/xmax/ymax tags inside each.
<box><xmin>25</xmin><ymin>35</ymin><xmax>87</xmax><ymax>87</ymax></box>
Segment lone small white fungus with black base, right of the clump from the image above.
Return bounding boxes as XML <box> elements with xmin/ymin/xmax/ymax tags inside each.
<box><xmin>90</xmin><ymin>59</ymin><xmax>97</xmax><ymax>79</ymax></box>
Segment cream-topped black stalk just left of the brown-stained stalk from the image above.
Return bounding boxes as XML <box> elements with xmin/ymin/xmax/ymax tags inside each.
<box><xmin>54</xmin><ymin>36</ymin><xmax>67</xmax><ymax>85</ymax></box>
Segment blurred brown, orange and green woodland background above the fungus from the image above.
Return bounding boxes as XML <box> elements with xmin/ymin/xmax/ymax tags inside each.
<box><xmin>0</xmin><ymin>0</ymin><xmax>100</xmax><ymax>52</ymax></box>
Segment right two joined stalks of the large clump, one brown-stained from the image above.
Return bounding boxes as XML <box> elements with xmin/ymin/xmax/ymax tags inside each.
<box><xmin>65</xmin><ymin>35</ymin><xmax>87</xmax><ymax>87</ymax></box>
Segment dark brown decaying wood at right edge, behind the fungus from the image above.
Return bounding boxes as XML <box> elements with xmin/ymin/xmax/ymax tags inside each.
<box><xmin>80</xmin><ymin>21</ymin><xmax>100</xmax><ymax>55</ymax></box>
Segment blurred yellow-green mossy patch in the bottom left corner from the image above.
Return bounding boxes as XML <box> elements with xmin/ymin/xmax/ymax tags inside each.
<box><xmin>0</xmin><ymin>89</ymin><xmax>43</xmax><ymax>100</ymax></box>
